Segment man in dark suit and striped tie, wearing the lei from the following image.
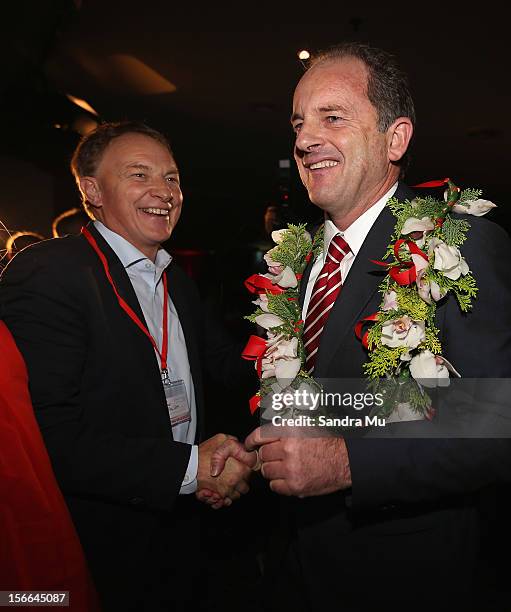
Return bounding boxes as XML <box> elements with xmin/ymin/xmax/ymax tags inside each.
<box><xmin>212</xmin><ymin>44</ymin><xmax>511</xmax><ymax>611</ymax></box>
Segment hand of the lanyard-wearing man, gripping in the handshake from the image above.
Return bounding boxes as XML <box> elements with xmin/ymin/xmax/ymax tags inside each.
<box><xmin>197</xmin><ymin>434</ymin><xmax>255</xmax><ymax>507</ymax></box>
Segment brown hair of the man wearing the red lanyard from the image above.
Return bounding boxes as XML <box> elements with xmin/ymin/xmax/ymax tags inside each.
<box><xmin>71</xmin><ymin>121</ymin><xmax>174</xmax><ymax>218</ymax></box>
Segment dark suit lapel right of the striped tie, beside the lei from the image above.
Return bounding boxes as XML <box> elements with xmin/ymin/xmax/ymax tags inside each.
<box><xmin>314</xmin><ymin>184</ymin><xmax>414</xmax><ymax>377</ymax></box>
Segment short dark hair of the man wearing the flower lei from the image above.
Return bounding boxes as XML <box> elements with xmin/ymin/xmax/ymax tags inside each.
<box><xmin>307</xmin><ymin>42</ymin><xmax>416</xmax><ymax>170</ymax></box>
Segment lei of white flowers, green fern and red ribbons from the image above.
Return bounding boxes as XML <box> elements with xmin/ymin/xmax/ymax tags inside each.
<box><xmin>243</xmin><ymin>179</ymin><xmax>495</xmax><ymax>418</ymax></box>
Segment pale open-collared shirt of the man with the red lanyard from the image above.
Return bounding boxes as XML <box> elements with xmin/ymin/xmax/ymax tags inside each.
<box><xmin>94</xmin><ymin>221</ymin><xmax>199</xmax><ymax>494</ymax></box>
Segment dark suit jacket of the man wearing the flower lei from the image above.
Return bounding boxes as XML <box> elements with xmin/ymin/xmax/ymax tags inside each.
<box><xmin>277</xmin><ymin>184</ymin><xmax>511</xmax><ymax>610</ymax></box>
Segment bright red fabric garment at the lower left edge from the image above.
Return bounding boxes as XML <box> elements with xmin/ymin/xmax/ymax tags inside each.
<box><xmin>0</xmin><ymin>321</ymin><xmax>100</xmax><ymax>612</ymax></box>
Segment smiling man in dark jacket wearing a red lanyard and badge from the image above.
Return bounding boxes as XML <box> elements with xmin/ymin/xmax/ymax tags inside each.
<box><xmin>0</xmin><ymin>122</ymin><xmax>256</xmax><ymax>611</ymax></box>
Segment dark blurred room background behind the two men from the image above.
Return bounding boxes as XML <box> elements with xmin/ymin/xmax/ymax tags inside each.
<box><xmin>0</xmin><ymin>0</ymin><xmax>511</xmax><ymax>610</ymax></box>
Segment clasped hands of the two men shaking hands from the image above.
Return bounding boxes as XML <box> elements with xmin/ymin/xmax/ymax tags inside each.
<box><xmin>196</xmin><ymin>434</ymin><xmax>260</xmax><ymax>510</ymax></box>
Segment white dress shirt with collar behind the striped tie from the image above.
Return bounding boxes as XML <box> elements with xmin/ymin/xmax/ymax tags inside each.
<box><xmin>302</xmin><ymin>182</ymin><xmax>397</xmax><ymax>321</ymax></box>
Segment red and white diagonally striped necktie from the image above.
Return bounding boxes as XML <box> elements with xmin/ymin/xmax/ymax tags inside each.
<box><xmin>303</xmin><ymin>234</ymin><xmax>350</xmax><ymax>374</ymax></box>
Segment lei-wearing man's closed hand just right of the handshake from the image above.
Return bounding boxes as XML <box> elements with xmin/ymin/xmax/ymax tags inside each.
<box><xmin>246</xmin><ymin>427</ymin><xmax>351</xmax><ymax>497</ymax></box>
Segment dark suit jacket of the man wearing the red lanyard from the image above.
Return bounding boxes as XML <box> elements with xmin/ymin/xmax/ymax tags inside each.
<box><xmin>0</xmin><ymin>227</ymin><xmax>246</xmax><ymax>609</ymax></box>
